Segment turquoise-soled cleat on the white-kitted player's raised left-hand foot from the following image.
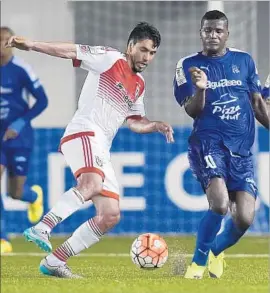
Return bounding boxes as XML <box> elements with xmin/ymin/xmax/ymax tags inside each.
<box><xmin>23</xmin><ymin>227</ymin><xmax>52</xmax><ymax>252</ymax></box>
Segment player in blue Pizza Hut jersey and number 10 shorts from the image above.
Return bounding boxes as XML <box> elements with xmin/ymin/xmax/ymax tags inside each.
<box><xmin>174</xmin><ymin>10</ymin><xmax>269</xmax><ymax>279</ymax></box>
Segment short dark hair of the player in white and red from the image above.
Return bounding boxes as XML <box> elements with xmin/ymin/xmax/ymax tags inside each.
<box><xmin>127</xmin><ymin>22</ymin><xmax>161</xmax><ymax>47</ymax></box>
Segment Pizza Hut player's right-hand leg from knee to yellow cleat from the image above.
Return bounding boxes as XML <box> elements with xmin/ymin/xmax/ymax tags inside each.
<box><xmin>208</xmin><ymin>191</ymin><xmax>255</xmax><ymax>278</ymax></box>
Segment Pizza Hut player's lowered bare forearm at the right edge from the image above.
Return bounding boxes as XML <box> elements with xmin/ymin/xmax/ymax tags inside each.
<box><xmin>252</xmin><ymin>93</ymin><xmax>270</xmax><ymax>129</ymax></box>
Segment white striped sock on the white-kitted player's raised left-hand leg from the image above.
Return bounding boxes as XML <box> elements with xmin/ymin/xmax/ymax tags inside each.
<box><xmin>35</xmin><ymin>188</ymin><xmax>85</xmax><ymax>233</ymax></box>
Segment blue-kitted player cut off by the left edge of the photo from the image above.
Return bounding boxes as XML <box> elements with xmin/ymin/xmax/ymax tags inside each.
<box><xmin>0</xmin><ymin>27</ymin><xmax>48</xmax><ymax>253</ymax></box>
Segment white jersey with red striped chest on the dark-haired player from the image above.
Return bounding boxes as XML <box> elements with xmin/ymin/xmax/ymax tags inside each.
<box><xmin>64</xmin><ymin>45</ymin><xmax>145</xmax><ymax>147</ymax></box>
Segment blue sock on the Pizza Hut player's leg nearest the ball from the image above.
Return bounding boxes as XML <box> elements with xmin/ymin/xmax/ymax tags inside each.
<box><xmin>192</xmin><ymin>210</ymin><xmax>224</xmax><ymax>266</ymax></box>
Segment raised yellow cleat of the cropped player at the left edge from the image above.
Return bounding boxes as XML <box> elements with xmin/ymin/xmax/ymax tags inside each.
<box><xmin>27</xmin><ymin>185</ymin><xmax>44</xmax><ymax>223</ymax></box>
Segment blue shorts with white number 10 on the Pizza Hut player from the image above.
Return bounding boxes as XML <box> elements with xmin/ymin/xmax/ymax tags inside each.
<box><xmin>188</xmin><ymin>139</ymin><xmax>257</xmax><ymax>198</ymax></box>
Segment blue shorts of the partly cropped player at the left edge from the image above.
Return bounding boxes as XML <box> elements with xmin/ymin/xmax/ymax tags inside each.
<box><xmin>0</xmin><ymin>147</ymin><xmax>32</xmax><ymax>177</ymax></box>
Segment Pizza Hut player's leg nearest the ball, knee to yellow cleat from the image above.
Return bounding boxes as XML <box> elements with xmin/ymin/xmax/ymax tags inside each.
<box><xmin>185</xmin><ymin>178</ymin><xmax>229</xmax><ymax>279</ymax></box>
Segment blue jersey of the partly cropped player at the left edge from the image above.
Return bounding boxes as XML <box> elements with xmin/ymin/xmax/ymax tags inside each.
<box><xmin>0</xmin><ymin>56</ymin><xmax>48</xmax><ymax>148</ymax></box>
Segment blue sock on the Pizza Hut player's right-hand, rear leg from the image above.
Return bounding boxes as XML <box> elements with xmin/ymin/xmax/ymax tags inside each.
<box><xmin>211</xmin><ymin>217</ymin><xmax>246</xmax><ymax>255</ymax></box>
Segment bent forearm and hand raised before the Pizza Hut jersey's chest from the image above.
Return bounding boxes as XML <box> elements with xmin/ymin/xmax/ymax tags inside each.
<box><xmin>185</xmin><ymin>67</ymin><xmax>207</xmax><ymax>118</ymax></box>
